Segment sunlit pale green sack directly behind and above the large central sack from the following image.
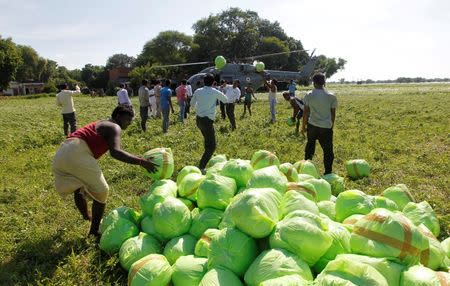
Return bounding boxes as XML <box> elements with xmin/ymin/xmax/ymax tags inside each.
<box><xmin>247</xmin><ymin>166</ymin><xmax>288</xmax><ymax>194</ymax></box>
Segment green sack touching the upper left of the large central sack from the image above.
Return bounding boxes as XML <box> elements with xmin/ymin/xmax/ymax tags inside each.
<box><xmin>197</xmin><ymin>174</ymin><xmax>237</xmax><ymax>210</ymax></box>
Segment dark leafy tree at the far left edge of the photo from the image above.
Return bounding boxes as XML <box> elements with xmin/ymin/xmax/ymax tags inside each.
<box><xmin>0</xmin><ymin>36</ymin><xmax>21</xmax><ymax>89</ymax></box>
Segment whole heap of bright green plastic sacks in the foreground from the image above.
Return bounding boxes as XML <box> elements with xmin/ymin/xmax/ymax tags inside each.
<box><xmin>99</xmin><ymin>151</ymin><xmax>450</xmax><ymax>286</ymax></box>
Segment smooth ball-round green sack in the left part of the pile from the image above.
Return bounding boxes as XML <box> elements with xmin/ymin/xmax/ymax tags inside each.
<box><xmin>152</xmin><ymin>198</ymin><xmax>191</xmax><ymax>239</ymax></box>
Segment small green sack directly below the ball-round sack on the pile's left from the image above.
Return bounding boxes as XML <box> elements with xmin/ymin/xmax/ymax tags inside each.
<box><xmin>163</xmin><ymin>234</ymin><xmax>197</xmax><ymax>265</ymax></box>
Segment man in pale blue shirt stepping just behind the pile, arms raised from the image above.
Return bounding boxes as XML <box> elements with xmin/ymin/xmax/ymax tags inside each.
<box><xmin>191</xmin><ymin>74</ymin><xmax>228</xmax><ymax>172</ymax></box>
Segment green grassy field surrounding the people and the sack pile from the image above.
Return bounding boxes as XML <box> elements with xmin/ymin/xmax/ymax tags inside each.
<box><xmin>0</xmin><ymin>84</ymin><xmax>450</xmax><ymax>285</ymax></box>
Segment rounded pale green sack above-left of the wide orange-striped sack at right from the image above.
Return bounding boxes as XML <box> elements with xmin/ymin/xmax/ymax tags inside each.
<box><xmin>336</xmin><ymin>190</ymin><xmax>374</xmax><ymax>222</ymax></box>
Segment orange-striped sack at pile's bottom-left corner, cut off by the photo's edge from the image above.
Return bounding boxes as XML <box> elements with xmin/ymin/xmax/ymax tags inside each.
<box><xmin>128</xmin><ymin>254</ymin><xmax>173</xmax><ymax>286</ymax></box>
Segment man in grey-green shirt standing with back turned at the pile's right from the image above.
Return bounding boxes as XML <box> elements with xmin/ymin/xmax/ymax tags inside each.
<box><xmin>302</xmin><ymin>73</ymin><xmax>337</xmax><ymax>174</ymax></box>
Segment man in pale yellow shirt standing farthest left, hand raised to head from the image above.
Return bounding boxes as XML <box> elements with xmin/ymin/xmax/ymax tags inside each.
<box><xmin>56</xmin><ymin>83</ymin><xmax>81</xmax><ymax>136</ymax></box>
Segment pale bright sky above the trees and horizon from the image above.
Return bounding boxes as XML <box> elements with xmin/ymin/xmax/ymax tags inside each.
<box><xmin>0</xmin><ymin>0</ymin><xmax>450</xmax><ymax>80</ymax></box>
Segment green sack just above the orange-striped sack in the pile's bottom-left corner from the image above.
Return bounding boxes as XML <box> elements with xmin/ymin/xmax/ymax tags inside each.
<box><xmin>119</xmin><ymin>232</ymin><xmax>161</xmax><ymax>271</ymax></box>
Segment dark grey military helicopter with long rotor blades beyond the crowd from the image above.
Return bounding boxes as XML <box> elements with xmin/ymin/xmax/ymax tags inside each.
<box><xmin>151</xmin><ymin>49</ymin><xmax>317</xmax><ymax>90</ymax></box>
